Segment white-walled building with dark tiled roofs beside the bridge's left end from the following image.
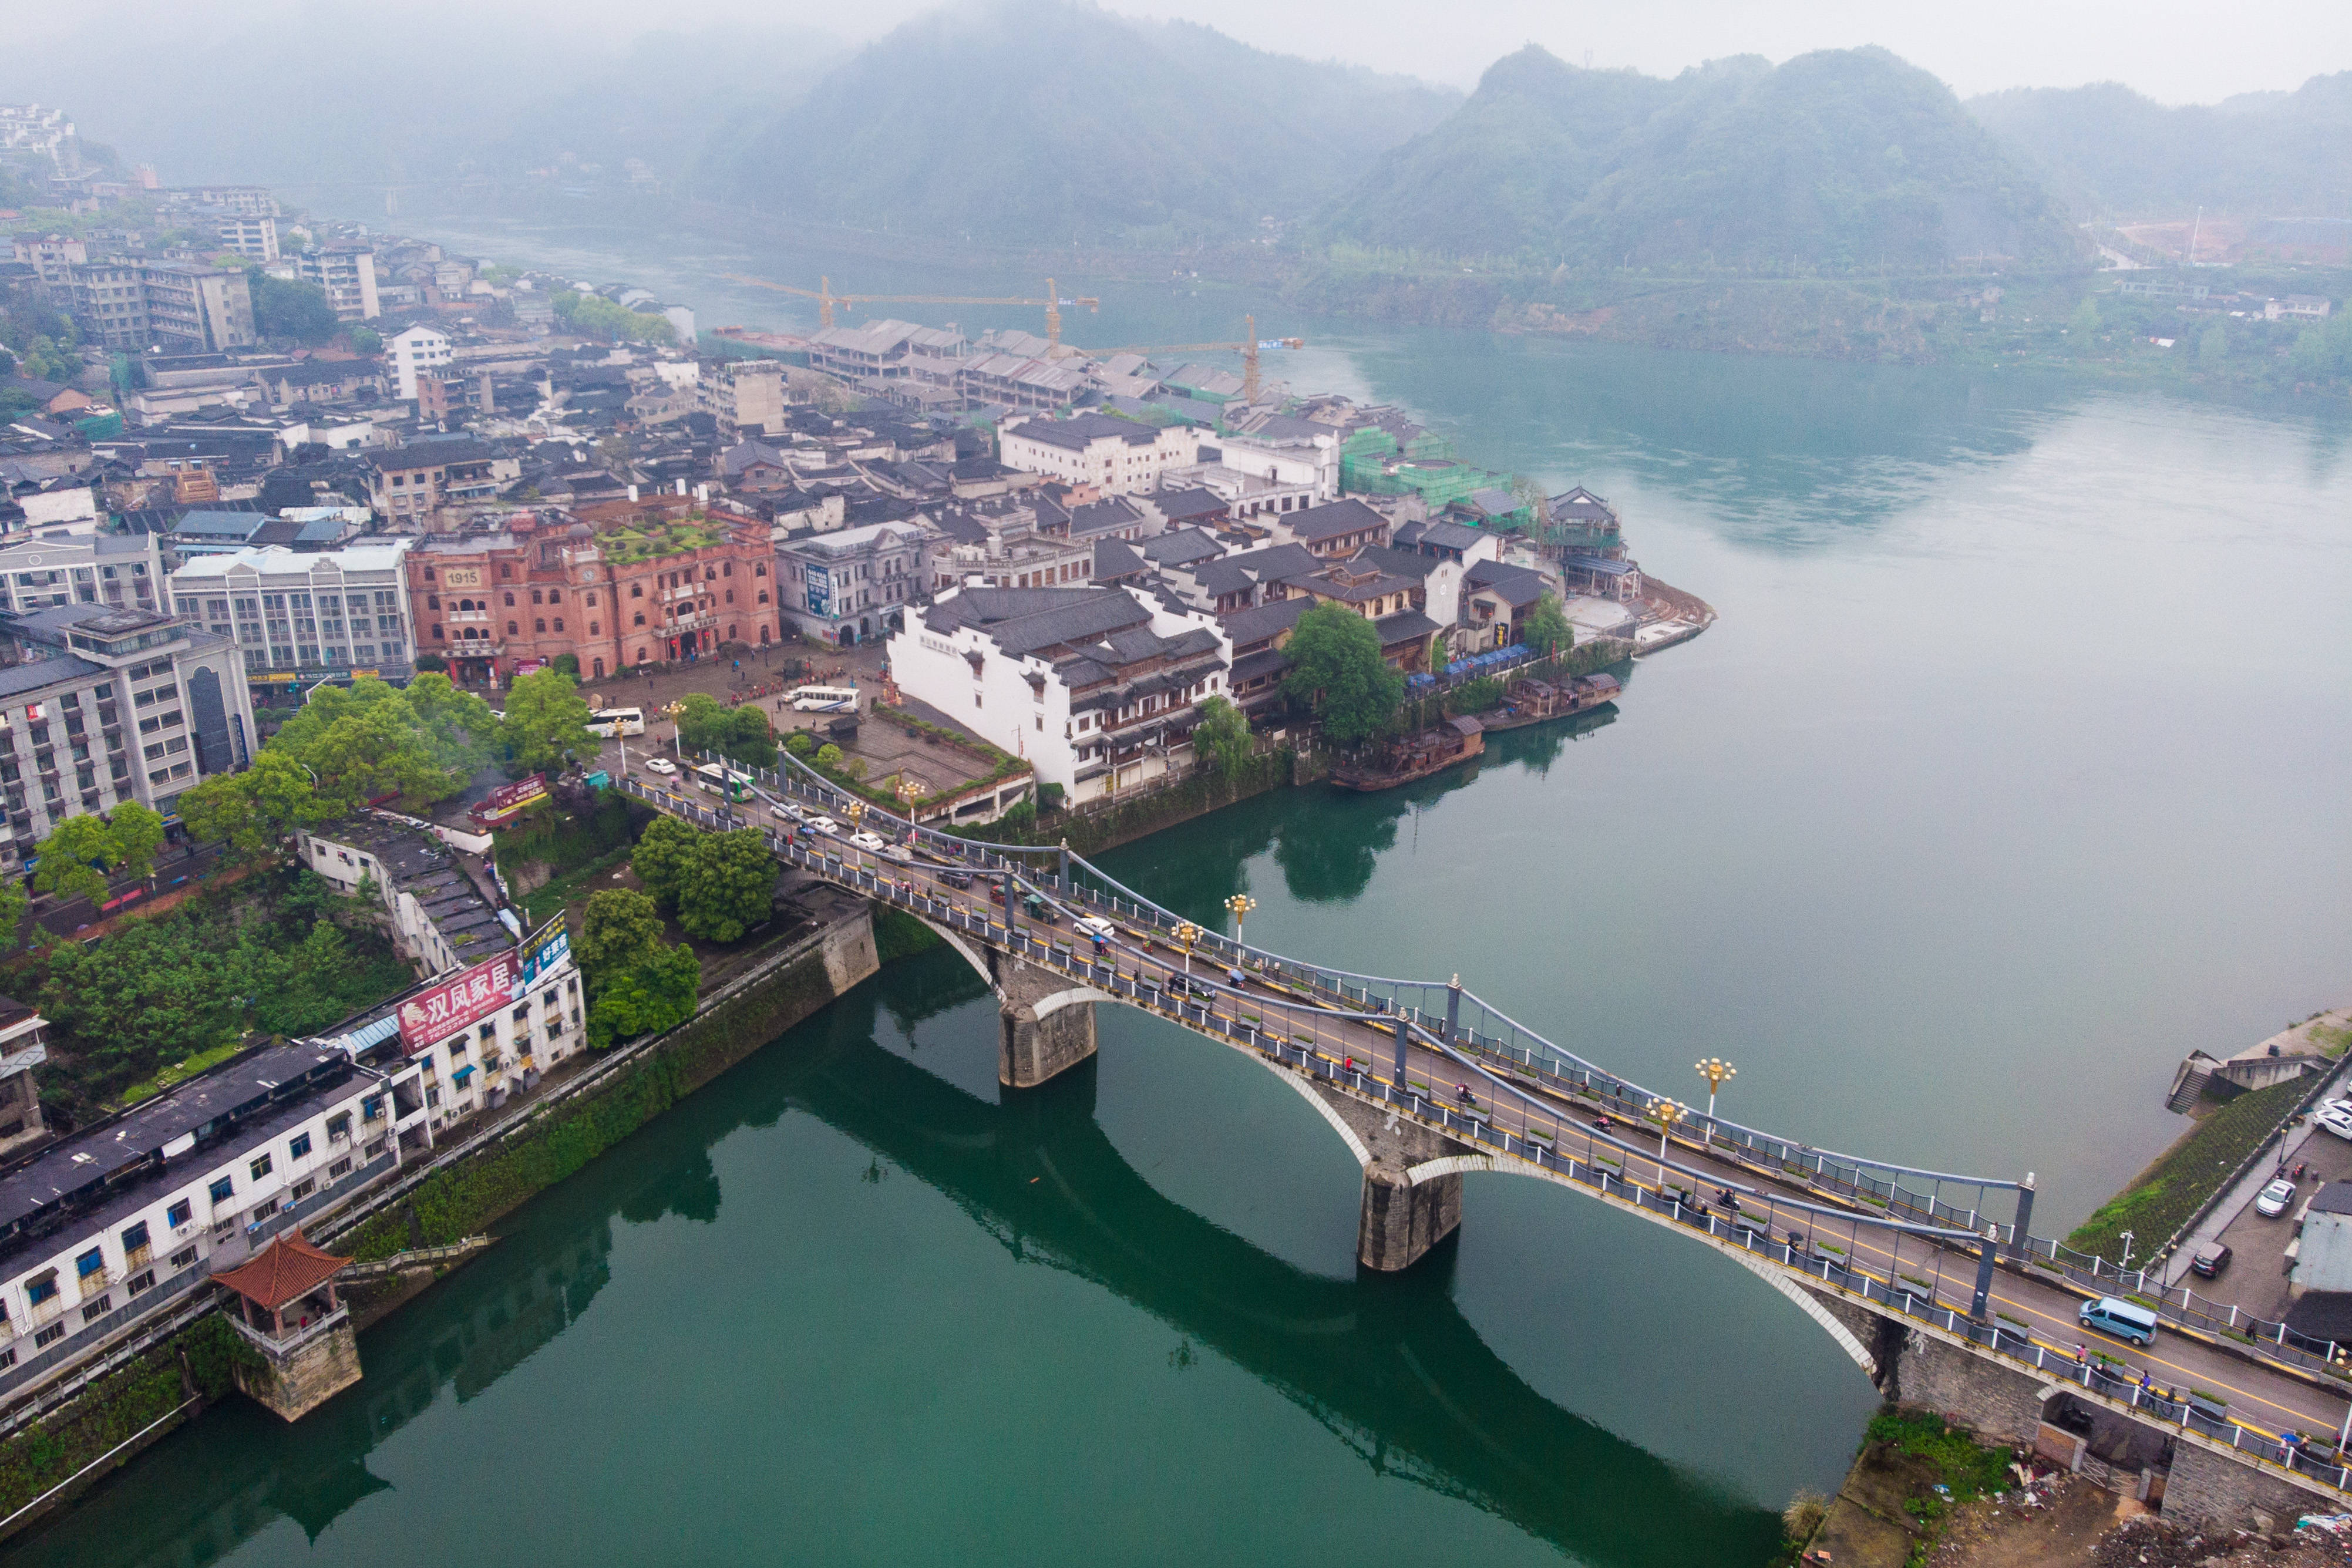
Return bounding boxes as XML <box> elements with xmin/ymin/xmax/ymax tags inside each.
<box><xmin>889</xmin><ymin>588</ymin><xmax>1233</xmax><ymax>802</ymax></box>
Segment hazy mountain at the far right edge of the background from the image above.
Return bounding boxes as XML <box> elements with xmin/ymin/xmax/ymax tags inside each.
<box><xmin>1969</xmin><ymin>70</ymin><xmax>2352</xmax><ymax>218</ymax></box>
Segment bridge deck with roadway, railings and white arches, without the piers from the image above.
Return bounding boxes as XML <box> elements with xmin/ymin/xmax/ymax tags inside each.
<box><xmin>621</xmin><ymin>773</ymin><xmax>2352</xmax><ymax>1505</ymax></box>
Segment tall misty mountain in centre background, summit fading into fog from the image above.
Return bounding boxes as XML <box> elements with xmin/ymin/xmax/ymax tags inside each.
<box><xmin>703</xmin><ymin>0</ymin><xmax>1461</xmax><ymax>244</ymax></box>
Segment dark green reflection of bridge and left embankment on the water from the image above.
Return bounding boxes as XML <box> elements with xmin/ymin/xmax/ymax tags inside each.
<box><xmin>7</xmin><ymin>952</ymin><xmax>1774</xmax><ymax>1568</ymax></box>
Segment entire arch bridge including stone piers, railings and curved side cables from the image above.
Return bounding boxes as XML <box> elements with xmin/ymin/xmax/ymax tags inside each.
<box><xmin>618</xmin><ymin>757</ymin><xmax>2352</xmax><ymax>1516</ymax></box>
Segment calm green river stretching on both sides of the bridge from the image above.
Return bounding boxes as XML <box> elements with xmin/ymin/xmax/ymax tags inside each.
<box><xmin>5</xmin><ymin>226</ymin><xmax>2352</xmax><ymax>1568</ymax></box>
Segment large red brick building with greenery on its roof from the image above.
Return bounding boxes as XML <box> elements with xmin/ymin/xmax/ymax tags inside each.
<box><xmin>407</xmin><ymin>508</ymin><xmax>781</xmax><ymax>689</ymax></box>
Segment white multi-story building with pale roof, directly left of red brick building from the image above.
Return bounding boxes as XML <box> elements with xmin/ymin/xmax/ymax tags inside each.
<box><xmin>169</xmin><ymin>539</ymin><xmax>416</xmax><ymax>684</ymax></box>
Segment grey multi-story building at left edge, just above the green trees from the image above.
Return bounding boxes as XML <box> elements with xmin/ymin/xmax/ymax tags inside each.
<box><xmin>0</xmin><ymin>604</ymin><xmax>257</xmax><ymax>872</ymax></box>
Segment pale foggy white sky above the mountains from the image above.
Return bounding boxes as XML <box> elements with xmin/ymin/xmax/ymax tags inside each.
<box><xmin>18</xmin><ymin>0</ymin><xmax>2352</xmax><ymax>103</ymax></box>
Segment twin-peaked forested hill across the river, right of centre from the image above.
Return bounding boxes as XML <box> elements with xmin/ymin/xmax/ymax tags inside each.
<box><xmin>1322</xmin><ymin>45</ymin><xmax>2081</xmax><ymax>272</ymax></box>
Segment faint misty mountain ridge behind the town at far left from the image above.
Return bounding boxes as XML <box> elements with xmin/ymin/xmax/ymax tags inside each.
<box><xmin>0</xmin><ymin>0</ymin><xmax>847</xmax><ymax>209</ymax></box>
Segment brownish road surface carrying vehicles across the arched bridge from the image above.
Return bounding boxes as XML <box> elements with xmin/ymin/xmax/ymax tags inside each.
<box><xmin>635</xmin><ymin>773</ymin><xmax>2352</xmax><ymax>1436</ymax></box>
